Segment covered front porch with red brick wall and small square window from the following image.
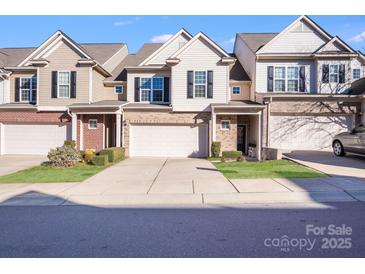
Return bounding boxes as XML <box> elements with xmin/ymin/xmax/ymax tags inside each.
<box><xmin>69</xmin><ymin>101</ymin><xmax>124</xmax><ymax>151</ymax></box>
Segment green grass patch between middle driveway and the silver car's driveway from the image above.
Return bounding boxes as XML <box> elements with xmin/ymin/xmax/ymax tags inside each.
<box><xmin>213</xmin><ymin>160</ymin><xmax>326</xmax><ymax>179</ymax></box>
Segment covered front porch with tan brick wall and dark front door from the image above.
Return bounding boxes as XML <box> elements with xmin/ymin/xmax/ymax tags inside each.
<box><xmin>211</xmin><ymin>101</ymin><xmax>264</xmax><ymax>160</ymax></box>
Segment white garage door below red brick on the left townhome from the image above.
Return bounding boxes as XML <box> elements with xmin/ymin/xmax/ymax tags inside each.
<box><xmin>3</xmin><ymin>124</ymin><xmax>71</xmax><ymax>155</ymax></box>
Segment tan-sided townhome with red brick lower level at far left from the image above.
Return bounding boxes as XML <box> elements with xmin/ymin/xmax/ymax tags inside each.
<box><xmin>0</xmin><ymin>31</ymin><xmax>128</xmax><ymax>154</ymax></box>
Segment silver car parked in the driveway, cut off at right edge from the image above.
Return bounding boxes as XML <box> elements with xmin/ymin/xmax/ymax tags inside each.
<box><xmin>332</xmin><ymin>123</ymin><xmax>365</xmax><ymax>156</ymax></box>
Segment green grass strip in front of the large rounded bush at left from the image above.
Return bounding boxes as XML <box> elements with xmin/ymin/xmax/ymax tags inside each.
<box><xmin>0</xmin><ymin>164</ymin><xmax>107</xmax><ymax>183</ymax></box>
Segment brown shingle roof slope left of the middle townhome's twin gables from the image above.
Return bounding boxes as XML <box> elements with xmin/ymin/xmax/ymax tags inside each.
<box><xmin>106</xmin><ymin>43</ymin><xmax>163</xmax><ymax>81</ymax></box>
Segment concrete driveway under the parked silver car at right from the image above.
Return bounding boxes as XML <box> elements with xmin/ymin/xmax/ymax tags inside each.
<box><xmin>285</xmin><ymin>151</ymin><xmax>365</xmax><ymax>178</ymax></box>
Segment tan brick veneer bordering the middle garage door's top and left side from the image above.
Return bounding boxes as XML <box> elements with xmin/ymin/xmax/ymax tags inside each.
<box><xmin>122</xmin><ymin>110</ymin><xmax>211</xmax><ymax>156</ymax></box>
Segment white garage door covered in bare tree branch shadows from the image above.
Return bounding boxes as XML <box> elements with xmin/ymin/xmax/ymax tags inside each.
<box><xmin>269</xmin><ymin>116</ymin><xmax>354</xmax><ymax>150</ymax></box>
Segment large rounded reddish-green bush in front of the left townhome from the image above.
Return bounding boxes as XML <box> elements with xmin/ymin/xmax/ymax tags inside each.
<box><xmin>44</xmin><ymin>145</ymin><xmax>81</xmax><ymax>167</ymax></box>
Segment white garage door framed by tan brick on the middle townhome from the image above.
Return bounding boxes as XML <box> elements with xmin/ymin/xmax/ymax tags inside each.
<box><xmin>130</xmin><ymin>125</ymin><xmax>208</xmax><ymax>157</ymax></box>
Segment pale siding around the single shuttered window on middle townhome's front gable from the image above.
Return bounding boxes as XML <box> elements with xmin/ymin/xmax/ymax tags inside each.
<box><xmin>171</xmin><ymin>39</ymin><xmax>229</xmax><ymax>111</ymax></box>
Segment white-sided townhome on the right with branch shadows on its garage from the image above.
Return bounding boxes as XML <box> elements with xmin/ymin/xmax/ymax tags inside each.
<box><xmin>234</xmin><ymin>16</ymin><xmax>365</xmax><ymax>150</ymax></box>
